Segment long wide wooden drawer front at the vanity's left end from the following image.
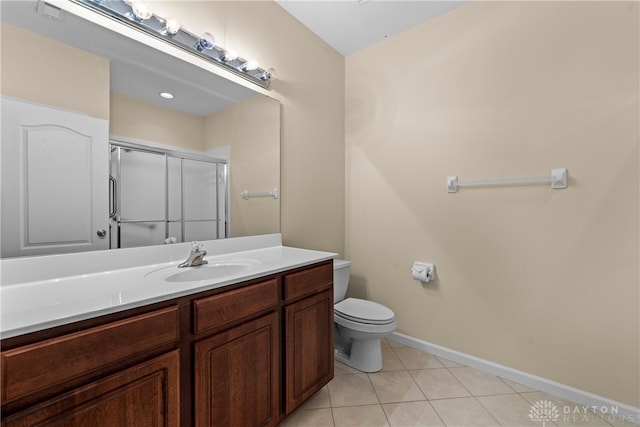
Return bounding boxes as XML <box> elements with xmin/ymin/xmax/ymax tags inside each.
<box><xmin>1</xmin><ymin>307</ymin><xmax>179</xmax><ymax>404</ymax></box>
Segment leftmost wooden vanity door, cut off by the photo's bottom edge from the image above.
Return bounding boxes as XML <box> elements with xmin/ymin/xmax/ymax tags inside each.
<box><xmin>2</xmin><ymin>350</ymin><xmax>180</xmax><ymax>427</ymax></box>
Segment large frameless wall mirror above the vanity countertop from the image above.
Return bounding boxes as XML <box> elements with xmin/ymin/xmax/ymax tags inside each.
<box><xmin>0</xmin><ymin>0</ymin><xmax>280</xmax><ymax>257</ymax></box>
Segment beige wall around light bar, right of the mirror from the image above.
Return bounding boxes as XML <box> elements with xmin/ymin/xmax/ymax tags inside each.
<box><xmin>154</xmin><ymin>1</ymin><xmax>345</xmax><ymax>252</ymax></box>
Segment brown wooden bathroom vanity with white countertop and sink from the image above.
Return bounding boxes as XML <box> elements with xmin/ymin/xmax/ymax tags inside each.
<box><xmin>0</xmin><ymin>235</ymin><xmax>334</xmax><ymax>426</ymax></box>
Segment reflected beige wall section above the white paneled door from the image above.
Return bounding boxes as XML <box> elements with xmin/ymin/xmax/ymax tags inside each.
<box><xmin>0</xmin><ymin>23</ymin><xmax>109</xmax><ymax>119</ymax></box>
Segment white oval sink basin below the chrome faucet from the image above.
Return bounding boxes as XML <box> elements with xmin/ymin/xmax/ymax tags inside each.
<box><xmin>147</xmin><ymin>260</ymin><xmax>259</xmax><ymax>283</ymax></box>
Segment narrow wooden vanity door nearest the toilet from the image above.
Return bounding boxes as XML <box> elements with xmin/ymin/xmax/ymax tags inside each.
<box><xmin>284</xmin><ymin>290</ymin><xmax>333</xmax><ymax>414</ymax></box>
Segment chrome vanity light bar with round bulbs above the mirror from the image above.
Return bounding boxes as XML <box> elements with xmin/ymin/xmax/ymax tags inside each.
<box><xmin>75</xmin><ymin>0</ymin><xmax>274</xmax><ymax>88</ymax></box>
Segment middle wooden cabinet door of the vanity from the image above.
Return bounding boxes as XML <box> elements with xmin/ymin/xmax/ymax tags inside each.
<box><xmin>194</xmin><ymin>313</ymin><xmax>280</xmax><ymax>427</ymax></box>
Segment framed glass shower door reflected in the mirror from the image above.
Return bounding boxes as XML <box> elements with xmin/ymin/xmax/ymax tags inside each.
<box><xmin>110</xmin><ymin>142</ymin><xmax>229</xmax><ymax>248</ymax></box>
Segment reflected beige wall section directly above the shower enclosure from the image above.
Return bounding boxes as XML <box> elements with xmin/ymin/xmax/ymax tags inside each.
<box><xmin>109</xmin><ymin>92</ymin><xmax>205</xmax><ymax>151</ymax></box>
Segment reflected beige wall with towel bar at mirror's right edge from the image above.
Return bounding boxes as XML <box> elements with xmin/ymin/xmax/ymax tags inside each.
<box><xmin>205</xmin><ymin>95</ymin><xmax>280</xmax><ymax>237</ymax></box>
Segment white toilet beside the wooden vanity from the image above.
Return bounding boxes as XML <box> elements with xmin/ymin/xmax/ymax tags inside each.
<box><xmin>333</xmin><ymin>259</ymin><xmax>396</xmax><ymax>372</ymax></box>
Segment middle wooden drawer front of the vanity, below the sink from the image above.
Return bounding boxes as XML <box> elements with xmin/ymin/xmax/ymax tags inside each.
<box><xmin>193</xmin><ymin>279</ymin><xmax>278</xmax><ymax>334</ymax></box>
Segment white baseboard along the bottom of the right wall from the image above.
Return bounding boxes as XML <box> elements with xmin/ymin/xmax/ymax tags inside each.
<box><xmin>388</xmin><ymin>332</ymin><xmax>640</xmax><ymax>424</ymax></box>
